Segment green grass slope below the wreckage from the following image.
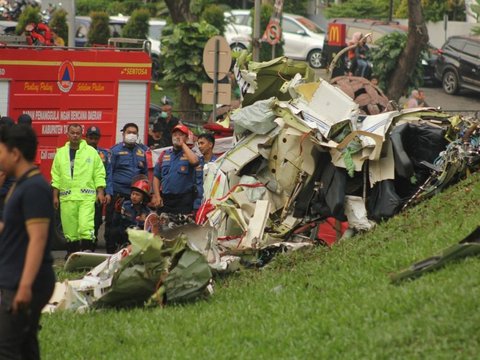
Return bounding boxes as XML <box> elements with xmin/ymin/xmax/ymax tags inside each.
<box><xmin>40</xmin><ymin>175</ymin><xmax>480</xmax><ymax>359</ymax></box>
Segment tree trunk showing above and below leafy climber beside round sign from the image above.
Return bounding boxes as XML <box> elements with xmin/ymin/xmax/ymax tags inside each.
<box><xmin>165</xmin><ymin>0</ymin><xmax>197</xmax><ymax>116</ymax></box>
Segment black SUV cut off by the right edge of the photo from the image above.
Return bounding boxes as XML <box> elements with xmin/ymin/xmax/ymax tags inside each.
<box><xmin>435</xmin><ymin>36</ymin><xmax>480</xmax><ymax>95</ymax></box>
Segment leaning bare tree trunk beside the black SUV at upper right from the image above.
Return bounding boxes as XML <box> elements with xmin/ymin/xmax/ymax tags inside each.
<box><xmin>386</xmin><ymin>0</ymin><xmax>428</xmax><ymax>102</ymax></box>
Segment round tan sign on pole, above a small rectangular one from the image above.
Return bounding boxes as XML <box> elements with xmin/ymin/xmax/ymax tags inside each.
<box><xmin>203</xmin><ymin>35</ymin><xmax>232</xmax><ymax>80</ymax></box>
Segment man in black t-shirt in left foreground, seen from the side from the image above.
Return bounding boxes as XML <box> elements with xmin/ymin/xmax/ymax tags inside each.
<box><xmin>0</xmin><ymin>125</ymin><xmax>55</xmax><ymax>359</ymax></box>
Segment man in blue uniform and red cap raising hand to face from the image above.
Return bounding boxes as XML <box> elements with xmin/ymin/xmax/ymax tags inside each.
<box><xmin>153</xmin><ymin>125</ymin><xmax>198</xmax><ymax>214</ymax></box>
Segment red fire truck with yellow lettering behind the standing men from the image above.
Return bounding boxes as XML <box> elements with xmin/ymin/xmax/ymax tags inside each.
<box><xmin>0</xmin><ymin>41</ymin><xmax>152</xmax><ymax>179</ymax></box>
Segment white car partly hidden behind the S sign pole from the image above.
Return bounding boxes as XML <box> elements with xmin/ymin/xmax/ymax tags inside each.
<box><xmin>225</xmin><ymin>10</ymin><xmax>325</xmax><ymax>69</ymax></box>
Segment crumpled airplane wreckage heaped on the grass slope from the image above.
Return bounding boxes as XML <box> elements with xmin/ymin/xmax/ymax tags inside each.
<box><xmin>47</xmin><ymin>58</ymin><xmax>480</xmax><ymax>311</ymax></box>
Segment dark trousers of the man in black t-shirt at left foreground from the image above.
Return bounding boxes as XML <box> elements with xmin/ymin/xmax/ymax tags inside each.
<box><xmin>0</xmin><ymin>284</ymin><xmax>55</xmax><ymax>360</ymax></box>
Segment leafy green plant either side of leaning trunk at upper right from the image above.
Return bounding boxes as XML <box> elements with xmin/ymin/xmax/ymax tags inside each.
<box><xmin>371</xmin><ymin>32</ymin><xmax>423</xmax><ymax>92</ymax></box>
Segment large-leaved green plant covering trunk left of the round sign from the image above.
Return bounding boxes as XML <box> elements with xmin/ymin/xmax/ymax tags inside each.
<box><xmin>161</xmin><ymin>21</ymin><xmax>219</xmax><ymax>103</ymax></box>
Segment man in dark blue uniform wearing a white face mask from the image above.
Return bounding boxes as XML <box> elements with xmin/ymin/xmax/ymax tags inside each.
<box><xmin>105</xmin><ymin>123</ymin><xmax>148</xmax><ymax>254</ymax></box>
